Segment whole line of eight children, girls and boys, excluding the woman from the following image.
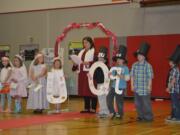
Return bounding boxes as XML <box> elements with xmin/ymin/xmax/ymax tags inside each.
<box><xmin>0</xmin><ymin>43</ymin><xmax>180</xmax><ymax>121</ymax></box>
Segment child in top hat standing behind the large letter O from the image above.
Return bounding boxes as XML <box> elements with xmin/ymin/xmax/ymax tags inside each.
<box><xmin>93</xmin><ymin>46</ymin><xmax>109</xmax><ymax>118</ymax></box>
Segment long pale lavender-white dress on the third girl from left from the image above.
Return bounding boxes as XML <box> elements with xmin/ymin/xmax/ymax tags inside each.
<box><xmin>27</xmin><ymin>64</ymin><xmax>49</xmax><ymax>109</ymax></box>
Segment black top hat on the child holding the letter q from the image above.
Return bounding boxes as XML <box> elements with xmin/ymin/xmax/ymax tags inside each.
<box><xmin>112</xmin><ymin>45</ymin><xmax>127</xmax><ymax>61</ymax></box>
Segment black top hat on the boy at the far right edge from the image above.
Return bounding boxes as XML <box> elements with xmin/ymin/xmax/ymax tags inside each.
<box><xmin>169</xmin><ymin>44</ymin><xmax>180</xmax><ymax>64</ymax></box>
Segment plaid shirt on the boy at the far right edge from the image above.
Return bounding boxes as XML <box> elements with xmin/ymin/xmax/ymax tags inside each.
<box><xmin>168</xmin><ymin>66</ymin><xmax>180</xmax><ymax>93</ymax></box>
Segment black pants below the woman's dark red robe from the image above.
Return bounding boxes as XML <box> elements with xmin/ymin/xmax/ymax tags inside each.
<box><xmin>84</xmin><ymin>97</ymin><xmax>97</xmax><ymax>110</ymax></box>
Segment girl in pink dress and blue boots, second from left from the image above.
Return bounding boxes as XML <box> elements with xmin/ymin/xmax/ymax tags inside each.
<box><xmin>10</xmin><ymin>55</ymin><xmax>27</xmax><ymax>113</ymax></box>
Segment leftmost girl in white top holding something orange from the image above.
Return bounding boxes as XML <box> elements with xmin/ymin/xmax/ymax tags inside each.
<box><xmin>0</xmin><ymin>56</ymin><xmax>12</xmax><ymax>112</ymax></box>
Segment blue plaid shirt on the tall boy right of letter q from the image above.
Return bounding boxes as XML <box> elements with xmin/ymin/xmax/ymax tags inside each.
<box><xmin>131</xmin><ymin>61</ymin><xmax>153</xmax><ymax>95</ymax></box>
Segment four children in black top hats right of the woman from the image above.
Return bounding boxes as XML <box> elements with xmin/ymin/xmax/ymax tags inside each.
<box><xmin>94</xmin><ymin>43</ymin><xmax>180</xmax><ymax>122</ymax></box>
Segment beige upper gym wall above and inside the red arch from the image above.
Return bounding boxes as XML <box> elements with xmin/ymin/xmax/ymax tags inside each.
<box><xmin>0</xmin><ymin>4</ymin><xmax>180</xmax><ymax>62</ymax></box>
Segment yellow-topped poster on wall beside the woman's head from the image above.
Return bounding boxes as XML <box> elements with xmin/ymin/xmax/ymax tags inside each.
<box><xmin>69</xmin><ymin>42</ymin><xmax>83</xmax><ymax>58</ymax></box>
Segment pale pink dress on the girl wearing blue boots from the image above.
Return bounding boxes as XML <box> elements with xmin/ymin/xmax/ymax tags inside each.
<box><xmin>10</xmin><ymin>66</ymin><xmax>27</xmax><ymax>97</ymax></box>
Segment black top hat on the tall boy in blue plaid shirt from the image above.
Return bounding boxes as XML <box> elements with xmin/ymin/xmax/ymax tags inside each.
<box><xmin>134</xmin><ymin>42</ymin><xmax>150</xmax><ymax>57</ymax></box>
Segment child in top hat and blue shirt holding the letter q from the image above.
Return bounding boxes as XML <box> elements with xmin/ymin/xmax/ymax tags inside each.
<box><xmin>107</xmin><ymin>45</ymin><xmax>130</xmax><ymax>119</ymax></box>
